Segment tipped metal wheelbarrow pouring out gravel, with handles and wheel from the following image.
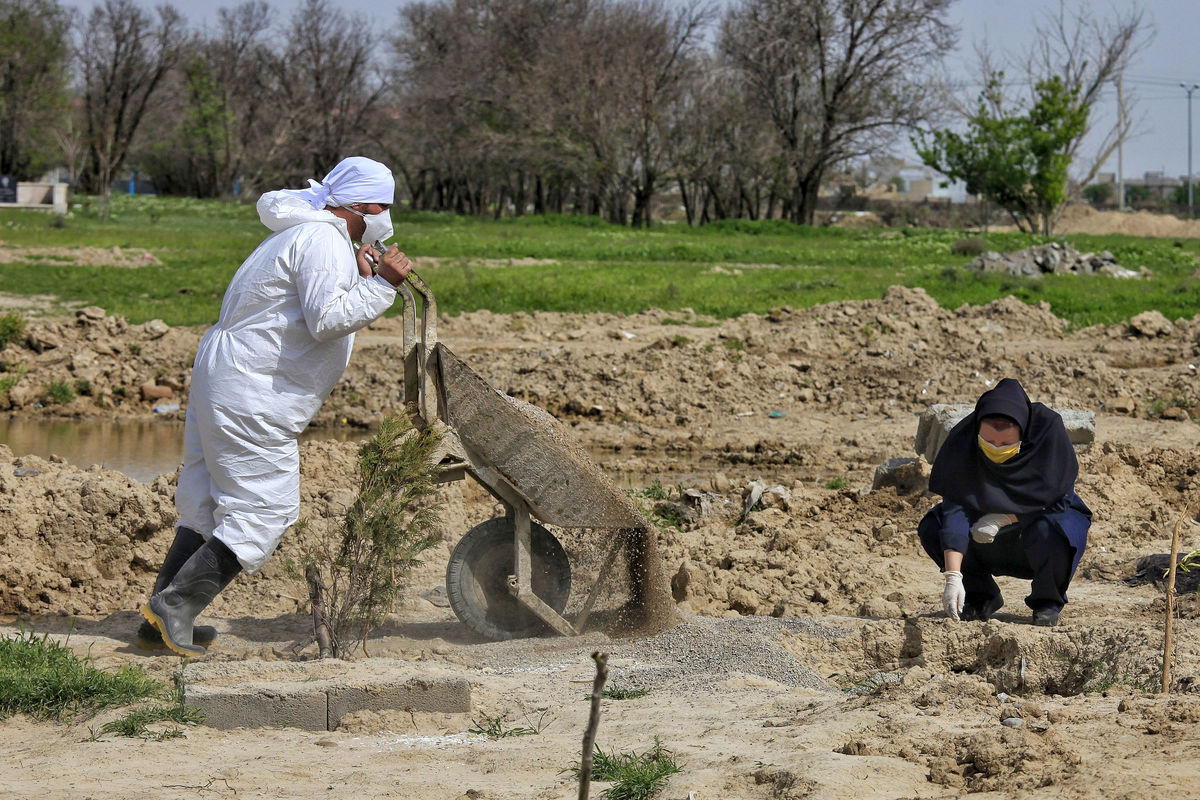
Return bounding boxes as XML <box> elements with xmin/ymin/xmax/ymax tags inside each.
<box><xmin>398</xmin><ymin>272</ymin><xmax>674</xmax><ymax>639</ymax></box>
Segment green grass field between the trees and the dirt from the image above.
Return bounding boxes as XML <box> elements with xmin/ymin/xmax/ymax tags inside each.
<box><xmin>0</xmin><ymin>196</ymin><xmax>1200</xmax><ymax>326</ymax></box>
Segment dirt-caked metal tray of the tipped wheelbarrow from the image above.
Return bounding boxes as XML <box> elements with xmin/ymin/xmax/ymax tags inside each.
<box><xmin>436</xmin><ymin>342</ymin><xmax>648</xmax><ymax>530</ymax></box>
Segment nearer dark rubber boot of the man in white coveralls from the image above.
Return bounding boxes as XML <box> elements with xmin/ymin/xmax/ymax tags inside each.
<box><xmin>142</xmin><ymin>536</ymin><xmax>241</xmax><ymax>656</ymax></box>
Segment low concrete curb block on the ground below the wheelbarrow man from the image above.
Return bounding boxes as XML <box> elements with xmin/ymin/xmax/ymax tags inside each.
<box><xmin>184</xmin><ymin>658</ymin><xmax>472</xmax><ymax>730</ymax></box>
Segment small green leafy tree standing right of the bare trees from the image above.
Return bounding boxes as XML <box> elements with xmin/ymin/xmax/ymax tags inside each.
<box><xmin>914</xmin><ymin>73</ymin><xmax>1088</xmax><ymax>235</ymax></box>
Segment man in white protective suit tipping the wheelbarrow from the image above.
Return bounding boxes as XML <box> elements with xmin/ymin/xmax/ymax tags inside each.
<box><xmin>138</xmin><ymin>157</ymin><xmax>413</xmax><ymax>656</ymax></box>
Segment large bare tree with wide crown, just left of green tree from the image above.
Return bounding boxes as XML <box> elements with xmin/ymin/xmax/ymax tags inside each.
<box><xmin>720</xmin><ymin>0</ymin><xmax>955</xmax><ymax>224</ymax></box>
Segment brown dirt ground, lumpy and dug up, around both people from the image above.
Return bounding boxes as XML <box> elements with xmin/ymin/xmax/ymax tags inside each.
<box><xmin>0</xmin><ymin>209</ymin><xmax>1200</xmax><ymax>800</ymax></box>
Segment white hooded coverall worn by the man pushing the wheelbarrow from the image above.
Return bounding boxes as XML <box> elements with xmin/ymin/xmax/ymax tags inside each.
<box><xmin>175</xmin><ymin>192</ymin><xmax>396</xmax><ymax>572</ymax></box>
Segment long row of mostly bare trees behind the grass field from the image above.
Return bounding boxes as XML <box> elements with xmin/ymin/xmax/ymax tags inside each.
<box><xmin>0</xmin><ymin>0</ymin><xmax>1141</xmax><ymax>225</ymax></box>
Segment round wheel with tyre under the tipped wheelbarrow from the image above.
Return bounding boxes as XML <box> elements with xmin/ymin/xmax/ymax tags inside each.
<box><xmin>446</xmin><ymin>517</ymin><xmax>571</xmax><ymax>640</ymax></box>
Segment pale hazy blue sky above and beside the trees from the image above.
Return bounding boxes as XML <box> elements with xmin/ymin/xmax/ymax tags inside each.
<box><xmin>58</xmin><ymin>0</ymin><xmax>1200</xmax><ymax>178</ymax></box>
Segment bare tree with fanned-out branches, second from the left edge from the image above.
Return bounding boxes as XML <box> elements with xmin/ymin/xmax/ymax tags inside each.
<box><xmin>78</xmin><ymin>0</ymin><xmax>185</xmax><ymax>212</ymax></box>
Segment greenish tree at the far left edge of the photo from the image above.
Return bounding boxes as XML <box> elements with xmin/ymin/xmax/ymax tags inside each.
<box><xmin>0</xmin><ymin>0</ymin><xmax>71</xmax><ymax>179</ymax></box>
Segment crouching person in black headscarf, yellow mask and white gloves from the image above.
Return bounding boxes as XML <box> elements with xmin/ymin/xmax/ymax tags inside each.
<box><xmin>917</xmin><ymin>378</ymin><xmax>1092</xmax><ymax>626</ymax></box>
